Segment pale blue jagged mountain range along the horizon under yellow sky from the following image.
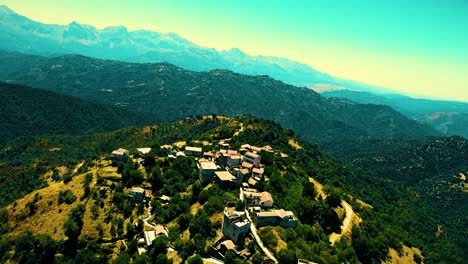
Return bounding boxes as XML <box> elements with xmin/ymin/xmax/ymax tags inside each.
<box><xmin>0</xmin><ymin>3</ymin><xmax>392</xmax><ymax>92</ymax></box>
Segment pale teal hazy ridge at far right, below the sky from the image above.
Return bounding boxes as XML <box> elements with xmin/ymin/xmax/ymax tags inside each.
<box><xmin>321</xmin><ymin>90</ymin><xmax>468</xmax><ymax>138</ymax></box>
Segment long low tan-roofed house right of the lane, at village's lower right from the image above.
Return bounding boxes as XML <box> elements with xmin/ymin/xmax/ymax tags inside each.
<box><xmin>252</xmin><ymin>209</ymin><xmax>298</xmax><ymax>228</ymax></box>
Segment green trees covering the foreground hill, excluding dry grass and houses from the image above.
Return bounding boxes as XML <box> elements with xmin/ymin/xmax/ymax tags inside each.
<box><xmin>0</xmin><ymin>116</ymin><xmax>466</xmax><ymax>263</ymax></box>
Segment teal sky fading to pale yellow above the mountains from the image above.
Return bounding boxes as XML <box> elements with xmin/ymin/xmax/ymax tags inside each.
<box><xmin>0</xmin><ymin>0</ymin><xmax>468</xmax><ymax>101</ymax></box>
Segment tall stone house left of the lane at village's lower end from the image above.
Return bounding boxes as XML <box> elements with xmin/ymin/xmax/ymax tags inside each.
<box><xmin>223</xmin><ymin>207</ymin><xmax>251</xmax><ymax>243</ymax></box>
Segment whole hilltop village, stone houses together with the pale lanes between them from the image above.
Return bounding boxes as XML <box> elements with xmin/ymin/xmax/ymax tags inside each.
<box><xmin>111</xmin><ymin>140</ymin><xmax>304</xmax><ymax>263</ymax></box>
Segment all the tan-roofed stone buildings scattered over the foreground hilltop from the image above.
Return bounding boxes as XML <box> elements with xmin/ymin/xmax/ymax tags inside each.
<box><xmin>112</xmin><ymin>141</ymin><xmax>298</xmax><ymax>260</ymax></box>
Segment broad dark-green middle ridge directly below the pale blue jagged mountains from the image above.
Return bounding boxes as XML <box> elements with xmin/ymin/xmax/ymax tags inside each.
<box><xmin>0</xmin><ymin>52</ymin><xmax>437</xmax><ymax>145</ymax></box>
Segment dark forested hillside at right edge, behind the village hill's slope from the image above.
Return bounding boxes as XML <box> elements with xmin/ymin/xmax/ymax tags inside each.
<box><xmin>324</xmin><ymin>137</ymin><xmax>468</xmax><ymax>263</ymax></box>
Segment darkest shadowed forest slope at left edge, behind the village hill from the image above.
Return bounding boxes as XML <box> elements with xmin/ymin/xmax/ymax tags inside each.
<box><xmin>0</xmin><ymin>83</ymin><xmax>156</xmax><ymax>145</ymax></box>
